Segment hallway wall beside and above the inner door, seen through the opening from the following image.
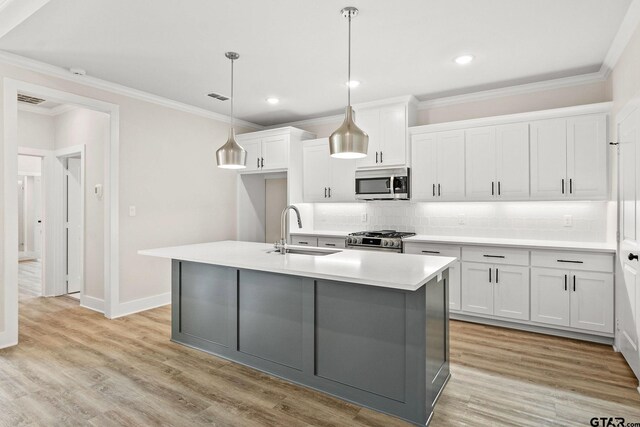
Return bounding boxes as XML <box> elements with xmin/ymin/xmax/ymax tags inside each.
<box><xmin>54</xmin><ymin>108</ymin><xmax>110</xmax><ymax>299</ymax></box>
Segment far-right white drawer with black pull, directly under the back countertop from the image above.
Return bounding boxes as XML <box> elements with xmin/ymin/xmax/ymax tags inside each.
<box><xmin>531</xmin><ymin>251</ymin><xmax>613</xmax><ymax>273</ymax></box>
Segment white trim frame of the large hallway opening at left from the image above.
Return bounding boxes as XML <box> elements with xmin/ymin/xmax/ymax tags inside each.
<box><xmin>0</xmin><ymin>78</ymin><xmax>120</xmax><ymax>348</ymax></box>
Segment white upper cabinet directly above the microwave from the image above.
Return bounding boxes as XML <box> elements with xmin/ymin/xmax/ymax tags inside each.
<box><xmin>354</xmin><ymin>98</ymin><xmax>415</xmax><ymax>169</ymax></box>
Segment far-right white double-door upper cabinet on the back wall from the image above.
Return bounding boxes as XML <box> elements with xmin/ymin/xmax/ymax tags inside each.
<box><xmin>531</xmin><ymin>114</ymin><xmax>608</xmax><ymax>200</ymax></box>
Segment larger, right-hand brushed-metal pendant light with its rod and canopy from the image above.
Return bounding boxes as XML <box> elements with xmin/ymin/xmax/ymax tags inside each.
<box><xmin>329</xmin><ymin>6</ymin><xmax>369</xmax><ymax>159</ymax></box>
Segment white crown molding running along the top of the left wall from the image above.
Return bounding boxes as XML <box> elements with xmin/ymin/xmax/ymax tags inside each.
<box><xmin>0</xmin><ymin>50</ymin><xmax>264</xmax><ymax>130</ymax></box>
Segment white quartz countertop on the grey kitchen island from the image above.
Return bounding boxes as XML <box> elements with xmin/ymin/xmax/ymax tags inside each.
<box><xmin>138</xmin><ymin>240</ymin><xmax>456</xmax><ymax>291</ymax></box>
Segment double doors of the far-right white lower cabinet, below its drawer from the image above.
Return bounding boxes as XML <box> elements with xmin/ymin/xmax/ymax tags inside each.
<box><xmin>531</xmin><ymin>267</ymin><xmax>613</xmax><ymax>333</ymax></box>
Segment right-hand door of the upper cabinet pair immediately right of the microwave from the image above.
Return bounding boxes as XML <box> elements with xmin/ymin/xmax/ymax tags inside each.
<box><xmin>436</xmin><ymin>131</ymin><xmax>465</xmax><ymax>200</ymax></box>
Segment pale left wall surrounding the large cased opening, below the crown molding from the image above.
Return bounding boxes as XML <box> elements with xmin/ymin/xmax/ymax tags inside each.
<box><xmin>0</xmin><ymin>60</ymin><xmax>246</xmax><ymax>333</ymax></box>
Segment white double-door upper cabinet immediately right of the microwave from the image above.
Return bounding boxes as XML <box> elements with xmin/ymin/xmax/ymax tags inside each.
<box><xmin>411</xmin><ymin>131</ymin><xmax>465</xmax><ymax>200</ymax></box>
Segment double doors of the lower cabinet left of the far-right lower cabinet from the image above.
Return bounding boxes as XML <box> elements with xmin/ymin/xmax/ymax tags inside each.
<box><xmin>462</xmin><ymin>262</ymin><xmax>529</xmax><ymax>320</ymax></box>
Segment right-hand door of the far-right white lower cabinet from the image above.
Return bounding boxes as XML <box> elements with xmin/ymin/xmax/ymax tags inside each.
<box><xmin>571</xmin><ymin>271</ymin><xmax>613</xmax><ymax>333</ymax></box>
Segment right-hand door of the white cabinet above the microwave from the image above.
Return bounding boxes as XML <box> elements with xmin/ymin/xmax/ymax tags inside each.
<box><xmin>380</xmin><ymin>105</ymin><xmax>407</xmax><ymax>166</ymax></box>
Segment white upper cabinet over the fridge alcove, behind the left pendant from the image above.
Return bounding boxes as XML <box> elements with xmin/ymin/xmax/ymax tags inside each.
<box><xmin>236</xmin><ymin>127</ymin><xmax>313</xmax><ymax>173</ymax></box>
